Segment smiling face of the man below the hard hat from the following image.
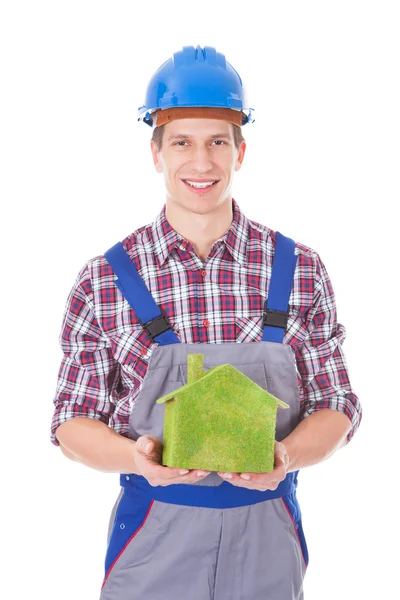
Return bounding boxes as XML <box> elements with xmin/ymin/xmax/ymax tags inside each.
<box><xmin>151</xmin><ymin>119</ymin><xmax>246</xmax><ymax>214</ymax></box>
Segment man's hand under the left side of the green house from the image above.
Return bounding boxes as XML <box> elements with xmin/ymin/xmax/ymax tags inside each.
<box><xmin>133</xmin><ymin>435</ymin><xmax>210</xmax><ymax>487</ymax></box>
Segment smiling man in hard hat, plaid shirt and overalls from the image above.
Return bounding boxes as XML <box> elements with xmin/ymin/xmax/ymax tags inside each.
<box><xmin>52</xmin><ymin>47</ymin><xmax>361</xmax><ymax>600</ymax></box>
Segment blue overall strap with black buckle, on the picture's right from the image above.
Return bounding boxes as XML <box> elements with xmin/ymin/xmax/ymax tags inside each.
<box><xmin>262</xmin><ymin>231</ymin><xmax>297</xmax><ymax>343</ymax></box>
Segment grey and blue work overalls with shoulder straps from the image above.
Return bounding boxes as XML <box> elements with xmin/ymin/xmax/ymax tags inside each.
<box><xmin>100</xmin><ymin>233</ymin><xmax>308</xmax><ymax>600</ymax></box>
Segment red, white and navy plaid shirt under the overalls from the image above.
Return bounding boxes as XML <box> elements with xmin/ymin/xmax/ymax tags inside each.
<box><xmin>51</xmin><ymin>200</ymin><xmax>361</xmax><ymax>445</ymax></box>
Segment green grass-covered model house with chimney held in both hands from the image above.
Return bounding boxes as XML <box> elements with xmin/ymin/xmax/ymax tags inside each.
<box><xmin>157</xmin><ymin>354</ymin><xmax>289</xmax><ymax>473</ymax></box>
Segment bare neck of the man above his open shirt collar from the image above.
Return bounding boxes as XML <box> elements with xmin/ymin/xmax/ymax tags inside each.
<box><xmin>165</xmin><ymin>198</ymin><xmax>233</xmax><ymax>262</ymax></box>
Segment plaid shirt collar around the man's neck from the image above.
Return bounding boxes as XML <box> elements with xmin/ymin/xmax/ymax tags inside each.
<box><xmin>151</xmin><ymin>198</ymin><xmax>250</xmax><ymax>267</ymax></box>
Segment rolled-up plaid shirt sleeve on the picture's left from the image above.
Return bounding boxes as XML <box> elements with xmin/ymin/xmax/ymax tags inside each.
<box><xmin>50</xmin><ymin>265</ymin><xmax>119</xmax><ymax>446</ymax></box>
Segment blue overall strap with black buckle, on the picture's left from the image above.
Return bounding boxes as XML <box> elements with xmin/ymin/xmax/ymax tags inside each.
<box><xmin>104</xmin><ymin>242</ymin><xmax>179</xmax><ymax>346</ymax></box>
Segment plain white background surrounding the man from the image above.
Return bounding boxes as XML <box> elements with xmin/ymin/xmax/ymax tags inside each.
<box><xmin>0</xmin><ymin>0</ymin><xmax>400</xmax><ymax>600</ymax></box>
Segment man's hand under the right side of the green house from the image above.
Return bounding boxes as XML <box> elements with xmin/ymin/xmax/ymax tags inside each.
<box><xmin>218</xmin><ymin>441</ymin><xmax>289</xmax><ymax>492</ymax></box>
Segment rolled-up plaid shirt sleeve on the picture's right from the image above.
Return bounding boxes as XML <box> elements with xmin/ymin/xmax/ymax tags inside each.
<box><xmin>296</xmin><ymin>254</ymin><xmax>362</xmax><ymax>443</ymax></box>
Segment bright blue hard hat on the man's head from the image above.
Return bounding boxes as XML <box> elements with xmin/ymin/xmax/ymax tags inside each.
<box><xmin>138</xmin><ymin>46</ymin><xmax>254</xmax><ymax>125</ymax></box>
